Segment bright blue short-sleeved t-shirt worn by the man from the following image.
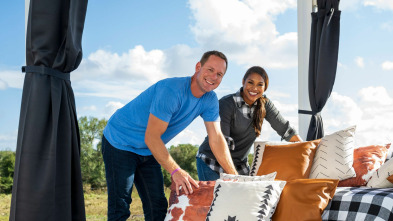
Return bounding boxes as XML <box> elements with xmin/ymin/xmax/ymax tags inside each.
<box><xmin>104</xmin><ymin>77</ymin><xmax>220</xmax><ymax>156</ymax></box>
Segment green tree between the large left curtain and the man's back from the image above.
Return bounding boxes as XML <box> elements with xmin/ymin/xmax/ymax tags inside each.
<box><xmin>78</xmin><ymin>117</ymin><xmax>107</xmax><ymax>189</ymax></box>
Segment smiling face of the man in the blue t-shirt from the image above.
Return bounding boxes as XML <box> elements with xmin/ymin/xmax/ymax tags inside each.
<box><xmin>195</xmin><ymin>55</ymin><xmax>226</xmax><ymax>93</ymax></box>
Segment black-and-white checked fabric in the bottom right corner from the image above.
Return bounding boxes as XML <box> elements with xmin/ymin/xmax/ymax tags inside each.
<box><xmin>322</xmin><ymin>187</ymin><xmax>393</xmax><ymax>221</ymax></box>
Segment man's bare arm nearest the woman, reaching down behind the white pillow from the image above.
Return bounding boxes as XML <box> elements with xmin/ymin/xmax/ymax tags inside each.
<box><xmin>205</xmin><ymin>121</ymin><xmax>237</xmax><ymax>174</ymax></box>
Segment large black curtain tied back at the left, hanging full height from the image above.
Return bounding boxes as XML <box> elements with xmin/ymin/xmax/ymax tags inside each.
<box><xmin>10</xmin><ymin>0</ymin><xmax>87</xmax><ymax>221</ymax></box>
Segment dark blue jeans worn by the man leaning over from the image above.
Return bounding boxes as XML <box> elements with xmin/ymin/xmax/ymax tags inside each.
<box><xmin>102</xmin><ymin>136</ymin><xmax>168</xmax><ymax>221</ymax></box>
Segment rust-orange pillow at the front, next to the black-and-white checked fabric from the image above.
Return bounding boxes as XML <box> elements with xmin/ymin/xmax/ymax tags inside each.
<box><xmin>272</xmin><ymin>179</ymin><xmax>338</xmax><ymax>221</ymax></box>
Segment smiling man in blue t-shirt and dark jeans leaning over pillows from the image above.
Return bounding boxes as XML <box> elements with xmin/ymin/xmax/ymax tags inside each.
<box><xmin>102</xmin><ymin>51</ymin><xmax>237</xmax><ymax>220</ymax></box>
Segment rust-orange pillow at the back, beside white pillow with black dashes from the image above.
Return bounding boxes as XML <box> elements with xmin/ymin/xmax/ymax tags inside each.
<box><xmin>257</xmin><ymin>140</ymin><xmax>319</xmax><ymax>181</ymax></box>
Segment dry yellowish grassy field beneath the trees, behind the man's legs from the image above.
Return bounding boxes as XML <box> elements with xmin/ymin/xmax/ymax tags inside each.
<box><xmin>0</xmin><ymin>188</ymin><xmax>170</xmax><ymax>221</ymax></box>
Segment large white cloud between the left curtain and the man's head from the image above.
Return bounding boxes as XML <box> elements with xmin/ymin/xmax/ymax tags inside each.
<box><xmin>71</xmin><ymin>45</ymin><xmax>202</xmax><ymax>100</ymax></box>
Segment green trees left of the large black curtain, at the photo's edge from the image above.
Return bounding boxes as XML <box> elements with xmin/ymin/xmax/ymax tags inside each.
<box><xmin>0</xmin><ymin>151</ymin><xmax>15</xmax><ymax>193</ymax></box>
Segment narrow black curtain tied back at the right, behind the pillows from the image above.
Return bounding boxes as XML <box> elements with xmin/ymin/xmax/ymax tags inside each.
<box><xmin>299</xmin><ymin>0</ymin><xmax>341</xmax><ymax>140</ymax></box>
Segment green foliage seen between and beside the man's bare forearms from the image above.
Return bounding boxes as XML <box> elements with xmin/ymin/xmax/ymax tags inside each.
<box><xmin>162</xmin><ymin>144</ymin><xmax>198</xmax><ymax>187</ymax></box>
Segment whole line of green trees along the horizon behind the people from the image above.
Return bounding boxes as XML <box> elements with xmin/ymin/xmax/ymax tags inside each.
<box><xmin>0</xmin><ymin>117</ymin><xmax>252</xmax><ymax>193</ymax></box>
